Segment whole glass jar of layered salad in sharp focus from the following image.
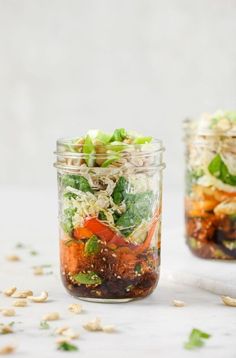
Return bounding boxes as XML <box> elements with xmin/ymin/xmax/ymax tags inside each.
<box><xmin>55</xmin><ymin>139</ymin><xmax>164</xmax><ymax>302</ymax></box>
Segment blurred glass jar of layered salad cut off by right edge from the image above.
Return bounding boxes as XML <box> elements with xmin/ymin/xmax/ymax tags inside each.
<box><xmin>185</xmin><ymin>111</ymin><xmax>236</xmax><ymax>260</ymax></box>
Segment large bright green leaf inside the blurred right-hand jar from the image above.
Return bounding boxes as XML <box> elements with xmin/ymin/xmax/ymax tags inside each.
<box><xmin>208</xmin><ymin>154</ymin><xmax>236</xmax><ymax>186</ymax></box>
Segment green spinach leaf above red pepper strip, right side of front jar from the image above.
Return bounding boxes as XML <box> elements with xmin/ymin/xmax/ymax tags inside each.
<box><xmin>116</xmin><ymin>191</ymin><xmax>154</xmax><ymax>236</ymax></box>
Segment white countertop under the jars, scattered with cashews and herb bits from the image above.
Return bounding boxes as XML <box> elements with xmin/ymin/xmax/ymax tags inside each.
<box><xmin>0</xmin><ymin>189</ymin><xmax>236</xmax><ymax>358</ymax></box>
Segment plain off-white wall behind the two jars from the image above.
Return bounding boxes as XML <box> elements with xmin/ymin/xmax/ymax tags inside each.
<box><xmin>0</xmin><ymin>0</ymin><xmax>236</xmax><ymax>190</ymax></box>
